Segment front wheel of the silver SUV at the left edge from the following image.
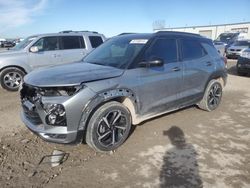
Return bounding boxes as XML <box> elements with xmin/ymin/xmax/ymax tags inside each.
<box><xmin>0</xmin><ymin>67</ymin><xmax>25</xmax><ymax>91</ymax></box>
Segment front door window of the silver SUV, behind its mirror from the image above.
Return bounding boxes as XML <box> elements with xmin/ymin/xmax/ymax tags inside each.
<box><xmin>33</xmin><ymin>37</ymin><xmax>59</xmax><ymax>51</ymax></box>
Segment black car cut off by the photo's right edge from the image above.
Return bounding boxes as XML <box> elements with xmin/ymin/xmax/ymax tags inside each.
<box><xmin>236</xmin><ymin>48</ymin><xmax>250</xmax><ymax>76</ymax></box>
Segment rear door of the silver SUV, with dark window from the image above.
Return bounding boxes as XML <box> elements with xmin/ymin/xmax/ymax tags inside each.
<box><xmin>60</xmin><ymin>36</ymin><xmax>87</xmax><ymax>64</ymax></box>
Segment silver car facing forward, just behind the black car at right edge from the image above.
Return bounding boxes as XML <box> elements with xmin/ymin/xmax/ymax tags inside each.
<box><xmin>226</xmin><ymin>40</ymin><xmax>250</xmax><ymax>59</ymax></box>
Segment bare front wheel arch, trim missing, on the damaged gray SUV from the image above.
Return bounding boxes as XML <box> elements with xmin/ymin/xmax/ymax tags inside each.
<box><xmin>78</xmin><ymin>88</ymin><xmax>138</xmax><ymax>130</ymax></box>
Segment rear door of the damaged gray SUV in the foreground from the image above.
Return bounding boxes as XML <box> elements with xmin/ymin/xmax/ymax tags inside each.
<box><xmin>180</xmin><ymin>39</ymin><xmax>215</xmax><ymax>106</ymax></box>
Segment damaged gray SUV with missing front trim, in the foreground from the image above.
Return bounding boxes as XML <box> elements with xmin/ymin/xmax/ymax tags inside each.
<box><xmin>20</xmin><ymin>32</ymin><xmax>227</xmax><ymax>151</ymax></box>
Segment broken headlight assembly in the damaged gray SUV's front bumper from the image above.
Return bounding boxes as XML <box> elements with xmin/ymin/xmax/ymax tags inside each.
<box><xmin>43</xmin><ymin>103</ymin><xmax>67</xmax><ymax>126</ymax></box>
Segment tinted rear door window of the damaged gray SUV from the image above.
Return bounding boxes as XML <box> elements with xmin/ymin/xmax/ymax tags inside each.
<box><xmin>182</xmin><ymin>39</ymin><xmax>206</xmax><ymax>60</ymax></box>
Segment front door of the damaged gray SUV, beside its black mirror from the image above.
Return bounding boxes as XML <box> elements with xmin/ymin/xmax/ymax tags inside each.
<box><xmin>137</xmin><ymin>38</ymin><xmax>182</xmax><ymax>115</ymax></box>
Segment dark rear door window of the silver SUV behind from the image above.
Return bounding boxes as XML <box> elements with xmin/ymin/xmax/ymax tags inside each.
<box><xmin>61</xmin><ymin>36</ymin><xmax>85</xmax><ymax>50</ymax></box>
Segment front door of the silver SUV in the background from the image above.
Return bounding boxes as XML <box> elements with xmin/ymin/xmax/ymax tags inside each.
<box><xmin>28</xmin><ymin>36</ymin><xmax>61</xmax><ymax>69</ymax></box>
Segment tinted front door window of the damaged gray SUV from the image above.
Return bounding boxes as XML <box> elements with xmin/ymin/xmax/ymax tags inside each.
<box><xmin>145</xmin><ymin>38</ymin><xmax>177</xmax><ymax>63</ymax></box>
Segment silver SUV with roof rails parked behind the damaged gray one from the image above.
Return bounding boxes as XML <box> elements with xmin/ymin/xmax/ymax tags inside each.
<box><xmin>0</xmin><ymin>31</ymin><xmax>105</xmax><ymax>91</ymax></box>
